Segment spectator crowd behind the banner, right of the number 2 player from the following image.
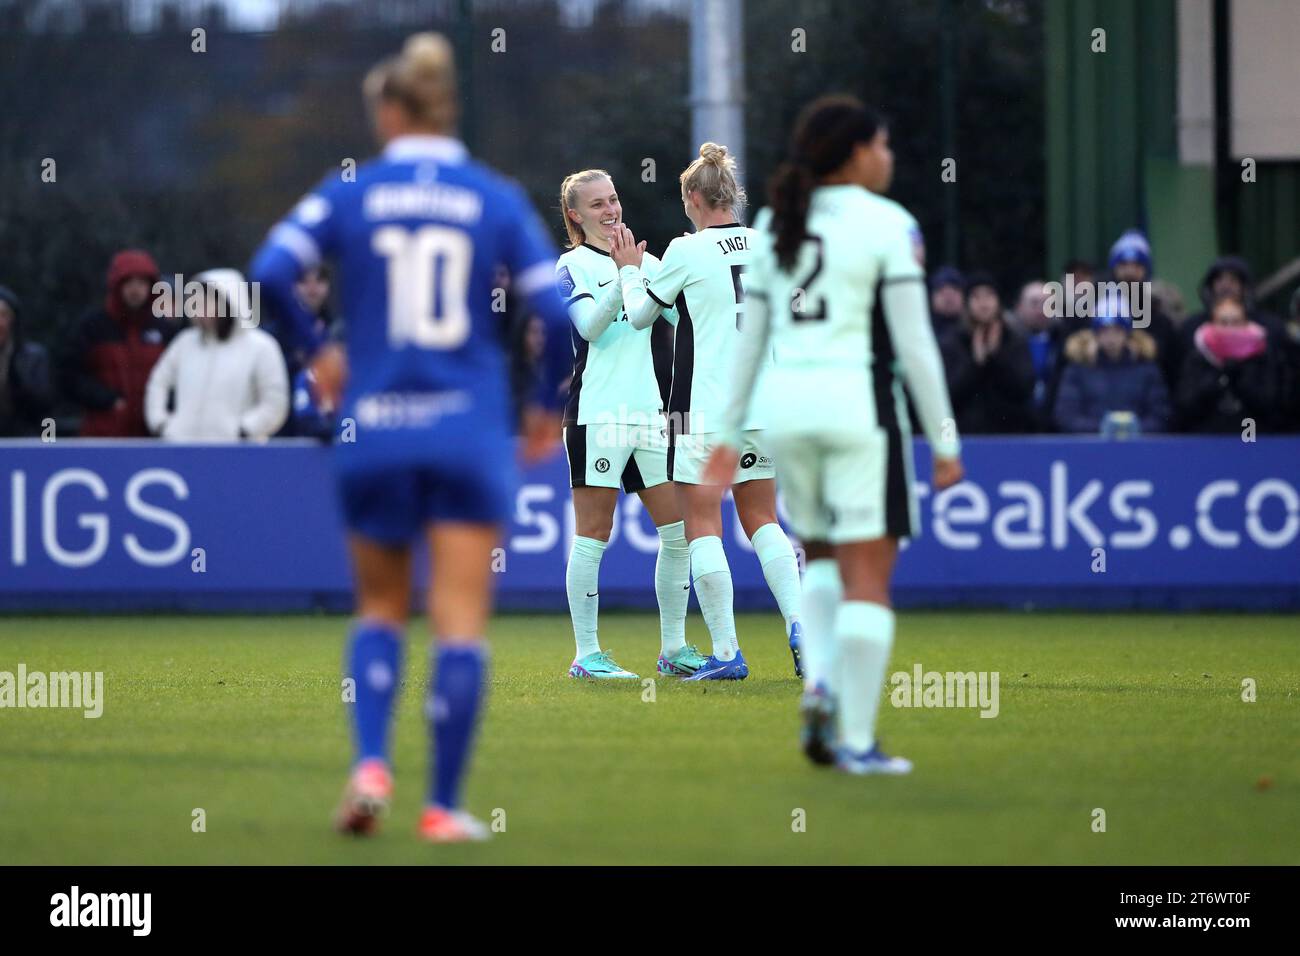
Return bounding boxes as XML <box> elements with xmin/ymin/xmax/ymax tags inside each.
<box><xmin>930</xmin><ymin>229</ymin><xmax>1300</xmax><ymax>437</ymax></box>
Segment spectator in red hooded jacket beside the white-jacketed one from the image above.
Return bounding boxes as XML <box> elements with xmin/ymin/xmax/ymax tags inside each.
<box><xmin>60</xmin><ymin>250</ymin><xmax>174</xmax><ymax>438</ymax></box>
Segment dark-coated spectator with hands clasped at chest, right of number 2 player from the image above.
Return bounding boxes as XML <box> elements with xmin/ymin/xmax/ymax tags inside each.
<box><xmin>944</xmin><ymin>272</ymin><xmax>1035</xmax><ymax>434</ymax></box>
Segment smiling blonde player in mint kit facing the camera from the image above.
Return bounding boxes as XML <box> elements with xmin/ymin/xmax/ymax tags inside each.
<box><xmin>555</xmin><ymin>169</ymin><xmax>705</xmax><ymax>680</ymax></box>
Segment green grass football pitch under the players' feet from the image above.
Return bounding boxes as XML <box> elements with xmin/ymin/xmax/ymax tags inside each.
<box><xmin>0</xmin><ymin>613</ymin><xmax>1300</xmax><ymax>864</ymax></box>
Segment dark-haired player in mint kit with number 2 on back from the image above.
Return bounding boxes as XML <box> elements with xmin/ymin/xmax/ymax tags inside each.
<box><xmin>706</xmin><ymin>96</ymin><xmax>962</xmax><ymax>774</ymax></box>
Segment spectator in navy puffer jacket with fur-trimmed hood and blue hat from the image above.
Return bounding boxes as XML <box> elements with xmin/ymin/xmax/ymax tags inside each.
<box><xmin>1054</xmin><ymin>308</ymin><xmax>1170</xmax><ymax>434</ymax></box>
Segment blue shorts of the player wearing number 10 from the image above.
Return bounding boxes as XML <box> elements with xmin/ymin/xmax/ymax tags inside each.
<box><xmin>338</xmin><ymin>458</ymin><xmax>516</xmax><ymax>548</ymax></box>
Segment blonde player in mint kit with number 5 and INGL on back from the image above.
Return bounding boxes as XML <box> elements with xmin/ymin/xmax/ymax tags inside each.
<box><xmin>614</xmin><ymin>143</ymin><xmax>800</xmax><ymax>680</ymax></box>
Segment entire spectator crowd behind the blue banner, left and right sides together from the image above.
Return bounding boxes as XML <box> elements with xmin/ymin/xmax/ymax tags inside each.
<box><xmin>0</xmin><ymin>230</ymin><xmax>1300</xmax><ymax>441</ymax></box>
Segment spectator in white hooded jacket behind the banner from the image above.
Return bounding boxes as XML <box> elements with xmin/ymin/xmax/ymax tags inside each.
<box><xmin>144</xmin><ymin>269</ymin><xmax>289</xmax><ymax>441</ymax></box>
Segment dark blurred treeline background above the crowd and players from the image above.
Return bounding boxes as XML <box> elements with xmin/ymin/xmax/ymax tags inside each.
<box><xmin>0</xmin><ymin>0</ymin><xmax>1045</xmax><ymax>342</ymax></box>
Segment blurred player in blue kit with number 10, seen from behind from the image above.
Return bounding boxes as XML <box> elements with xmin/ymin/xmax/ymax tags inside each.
<box><xmin>251</xmin><ymin>34</ymin><xmax>572</xmax><ymax>843</ymax></box>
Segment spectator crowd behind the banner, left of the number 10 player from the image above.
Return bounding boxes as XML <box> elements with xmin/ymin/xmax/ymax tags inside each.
<box><xmin>0</xmin><ymin>250</ymin><xmax>345</xmax><ymax>441</ymax></box>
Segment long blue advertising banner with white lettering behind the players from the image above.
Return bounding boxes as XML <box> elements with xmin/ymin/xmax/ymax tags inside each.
<box><xmin>0</xmin><ymin>437</ymin><xmax>1300</xmax><ymax>610</ymax></box>
